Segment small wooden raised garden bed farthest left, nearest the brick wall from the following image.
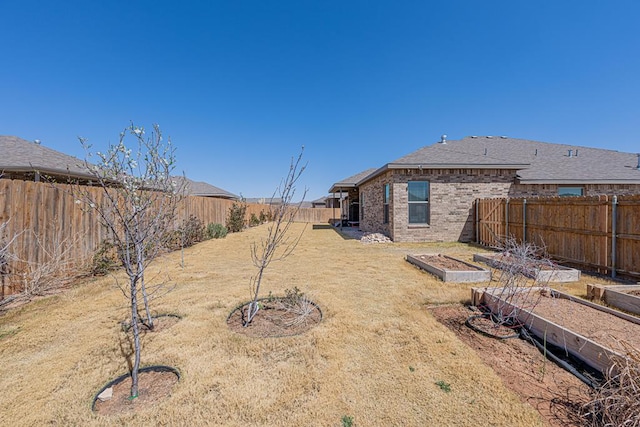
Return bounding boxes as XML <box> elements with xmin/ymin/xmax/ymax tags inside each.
<box><xmin>407</xmin><ymin>254</ymin><xmax>491</xmax><ymax>283</ymax></box>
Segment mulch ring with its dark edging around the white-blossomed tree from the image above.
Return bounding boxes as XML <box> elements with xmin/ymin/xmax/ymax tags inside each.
<box><xmin>91</xmin><ymin>365</ymin><xmax>180</xmax><ymax>415</ymax></box>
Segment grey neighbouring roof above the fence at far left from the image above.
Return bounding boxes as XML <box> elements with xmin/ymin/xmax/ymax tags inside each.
<box><xmin>0</xmin><ymin>136</ymin><xmax>92</xmax><ymax>179</ymax></box>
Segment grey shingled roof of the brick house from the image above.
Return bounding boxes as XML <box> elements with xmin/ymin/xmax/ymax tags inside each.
<box><xmin>358</xmin><ymin>136</ymin><xmax>640</xmax><ymax>185</ymax></box>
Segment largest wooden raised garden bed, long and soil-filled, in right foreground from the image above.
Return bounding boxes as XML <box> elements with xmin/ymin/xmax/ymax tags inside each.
<box><xmin>472</xmin><ymin>288</ymin><xmax>640</xmax><ymax>372</ymax></box>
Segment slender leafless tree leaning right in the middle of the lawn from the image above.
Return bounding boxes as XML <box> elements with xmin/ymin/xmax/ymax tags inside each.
<box><xmin>243</xmin><ymin>147</ymin><xmax>307</xmax><ymax>326</ymax></box>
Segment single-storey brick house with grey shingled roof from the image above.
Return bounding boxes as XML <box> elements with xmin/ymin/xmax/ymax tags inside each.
<box><xmin>329</xmin><ymin>136</ymin><xmax>640</xmax><ymax>242</ymax></box>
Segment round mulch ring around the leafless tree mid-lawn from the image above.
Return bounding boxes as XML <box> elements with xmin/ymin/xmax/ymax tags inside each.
<box><xmin>227</xmin><ymin>297</ymin><xmax>322</xmax><ymax>338</ymax></box>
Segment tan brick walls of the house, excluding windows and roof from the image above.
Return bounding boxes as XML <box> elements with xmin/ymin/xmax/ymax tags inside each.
<box><xmin>360</xmin><ymin>169</ymin><xmax>515</xmax><ymax>242</ymax></box>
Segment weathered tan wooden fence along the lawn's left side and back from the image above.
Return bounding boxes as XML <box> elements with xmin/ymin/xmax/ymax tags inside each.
<box><xmin>0</xmin><ymin>179</ymin><xmax>333</xmax><ymax>298</ymax></box>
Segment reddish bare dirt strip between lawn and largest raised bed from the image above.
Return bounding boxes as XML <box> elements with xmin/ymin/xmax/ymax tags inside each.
<box><xmin>429</xmin><ymin>304</ymin><xmax>589</xmax><ymax>427</ymax></box>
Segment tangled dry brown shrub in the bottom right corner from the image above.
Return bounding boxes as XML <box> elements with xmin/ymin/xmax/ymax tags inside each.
<box><xmin>582</xmin><ymin>341</ymin><xmax>640</xmax><ymax>427</ymax></box>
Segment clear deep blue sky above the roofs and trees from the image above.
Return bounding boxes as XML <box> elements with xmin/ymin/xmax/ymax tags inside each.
<box><xmin>0</xmin><ymin>0</ymin><xmax>640</xmax><ymax>200</ymax></box>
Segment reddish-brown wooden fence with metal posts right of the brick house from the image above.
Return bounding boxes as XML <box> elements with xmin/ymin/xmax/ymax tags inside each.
<box><xmin>475</xmin><ymin>195</ymin><xmax>640</xmax><ymax>278</ymax></box>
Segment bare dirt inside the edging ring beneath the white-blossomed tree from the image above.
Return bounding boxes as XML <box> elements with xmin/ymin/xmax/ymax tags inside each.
<box><xmin>94</xmin><ymin>371</ymin><xmax>179</xmax><ymax>415</ymax></box>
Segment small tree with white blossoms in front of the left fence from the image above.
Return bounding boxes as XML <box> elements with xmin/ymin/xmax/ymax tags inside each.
<box><xmin>74</xmin><ymin>124</ymin><xmax>185</xmax><ymax>398</ymax></box>
